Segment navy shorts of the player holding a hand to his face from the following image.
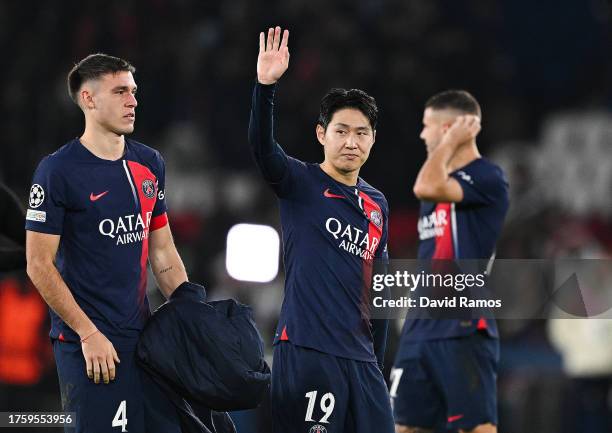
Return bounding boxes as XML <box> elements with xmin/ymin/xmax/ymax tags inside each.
<box><xmin>390</xmin><ymin>332</ymin><xmax>499</xmax><ymax>430</ymax></box>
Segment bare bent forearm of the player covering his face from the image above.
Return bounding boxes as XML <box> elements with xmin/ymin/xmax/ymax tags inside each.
<box><xmin>413</xmin><ymin>143</ymin><xmax>455</xmax><ymax>198</ymax></box>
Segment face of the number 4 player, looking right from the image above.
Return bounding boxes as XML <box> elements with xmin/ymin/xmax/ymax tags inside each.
<box><xmin>86</xmin><ymin>71</ymin><xmax>138</xmax><ymax>135</ymax></box>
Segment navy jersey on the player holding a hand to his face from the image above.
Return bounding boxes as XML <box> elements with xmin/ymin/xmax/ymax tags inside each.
<box><xmin>402</xmin><ymin>158</ymin><xmax>509</xmax><ymax>341</ymax></box>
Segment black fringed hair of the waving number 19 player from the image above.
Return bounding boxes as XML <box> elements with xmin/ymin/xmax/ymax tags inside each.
<box><xmin>317</xmin><ymin>89</ymin><xmax>378</xmax><ymax>129</ymax></box>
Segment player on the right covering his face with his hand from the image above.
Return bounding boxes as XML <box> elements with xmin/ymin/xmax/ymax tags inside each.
<box><xmin>391</xmin><ymin>91</ymin><xmax>508</xmax><ymax>433</ymax></box>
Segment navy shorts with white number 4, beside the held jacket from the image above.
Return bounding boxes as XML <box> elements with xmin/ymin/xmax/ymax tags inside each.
<box><xmin>53</xmin><ymin>340</ymin><xmax>181</xmax><ymax>433</ymax></box>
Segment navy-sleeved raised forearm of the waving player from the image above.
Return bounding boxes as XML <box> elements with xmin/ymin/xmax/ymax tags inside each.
<box><xmin>249</xmin><ymin>83</ymin><xmax>287</xmax><ymax>182</ymax></box>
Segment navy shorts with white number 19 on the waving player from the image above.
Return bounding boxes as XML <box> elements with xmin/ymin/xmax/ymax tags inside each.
<box><xmin>271</xmin><ymin>341</ymin><xmax>394</xmax><ymax>433</ymax></box>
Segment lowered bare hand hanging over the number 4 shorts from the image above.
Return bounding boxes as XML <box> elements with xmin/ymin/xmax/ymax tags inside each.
<box><xmin>81</xmin><ymin>331</ymin><xmax>121</xmax><ymax>383</ymax></box>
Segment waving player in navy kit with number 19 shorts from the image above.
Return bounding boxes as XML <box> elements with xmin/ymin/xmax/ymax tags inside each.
<box><xmin>249</xmin><ymin>27</ymin><xmax>393</xmax><ymax>433</ymax></box>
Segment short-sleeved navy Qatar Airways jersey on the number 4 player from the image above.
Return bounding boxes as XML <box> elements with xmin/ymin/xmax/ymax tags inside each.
<box><xmin>25</xmin><ymin>139</ymin><xmax>168</xmax><ymax>349</ymax></box>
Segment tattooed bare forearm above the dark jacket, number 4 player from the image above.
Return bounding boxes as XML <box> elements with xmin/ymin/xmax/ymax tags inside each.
<box><xmin>149</xmin><ymin>242</ymin><xmax>188</xmax><ymax>298</ymax></box>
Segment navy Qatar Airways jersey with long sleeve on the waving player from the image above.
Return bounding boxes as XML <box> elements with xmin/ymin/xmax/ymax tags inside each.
<box><xmin>249</xmin><ymin>84</ymin><xmax>389</xmax><ymax>363</ymax></box>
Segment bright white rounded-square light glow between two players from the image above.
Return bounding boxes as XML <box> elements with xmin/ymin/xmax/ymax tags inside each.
<box><xmin>225</xmin><ymin>224</ymin><xmax>280</xmax><ymax>283</ymax></box>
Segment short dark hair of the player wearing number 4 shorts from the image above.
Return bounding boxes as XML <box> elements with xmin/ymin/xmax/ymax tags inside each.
<box><xmin>67</xmin><ymin>53</ymin><xmax>136</xmax><ymax>105</ymax></box>
